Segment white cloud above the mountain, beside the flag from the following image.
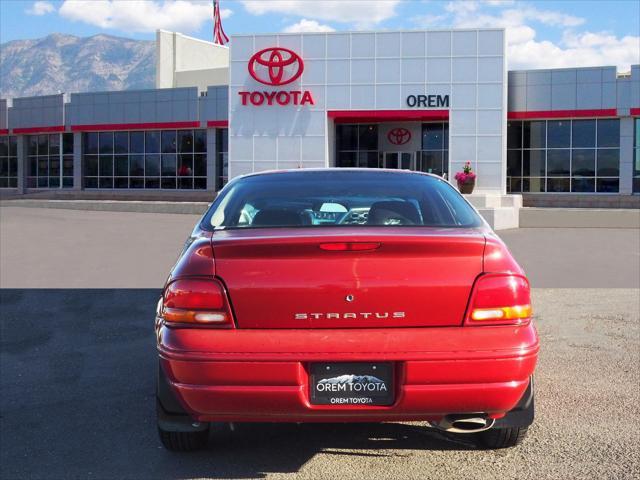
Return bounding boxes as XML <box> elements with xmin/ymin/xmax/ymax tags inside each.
<box><xmin>59</xmin><ymin>0</ymin><xmax>232</xmax><ymax>32</ymax></box>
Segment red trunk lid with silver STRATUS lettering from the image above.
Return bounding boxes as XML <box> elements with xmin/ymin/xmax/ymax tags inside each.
<box><xmin>212</xmin><ymin>227</ymin><xmax>485</xmax><ymax>328</ymax></box>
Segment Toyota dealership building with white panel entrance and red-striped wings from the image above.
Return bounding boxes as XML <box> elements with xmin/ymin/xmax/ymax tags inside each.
<box><xmin>0</xmin><ymin>29</ymin><xmax>640</xmax><ymax>227</ymax></box>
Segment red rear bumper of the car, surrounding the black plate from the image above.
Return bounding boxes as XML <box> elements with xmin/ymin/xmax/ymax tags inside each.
<box><xmin>157</xmin><ymin>324</ymin><xmax>539</xmax><ymax>422</ymax></box>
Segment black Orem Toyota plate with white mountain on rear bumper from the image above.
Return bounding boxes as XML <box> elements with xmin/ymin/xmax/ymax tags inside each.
<box><xmin>310</xmin><ymin>362</ymin><xmax>394</xmax><ymax>405</ymax></box>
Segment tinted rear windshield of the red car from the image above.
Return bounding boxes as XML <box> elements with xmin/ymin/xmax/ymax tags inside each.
<box><xmin>203</xmin><ymin>170</ymin><xmax>482</xmax><ymax>229</ymax></box>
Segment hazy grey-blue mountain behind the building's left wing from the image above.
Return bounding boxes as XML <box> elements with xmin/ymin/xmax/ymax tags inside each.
<box><xmin>0</xmin><ymin>33</ymin><xmax>156</xmax><ymax>98</ymax></box>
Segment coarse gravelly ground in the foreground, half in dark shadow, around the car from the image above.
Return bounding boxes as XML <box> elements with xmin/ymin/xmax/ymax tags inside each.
<box><xmin>0</xmin><ymin>289</ymin><xmax>640</xmax><ymax>480</ymax></box>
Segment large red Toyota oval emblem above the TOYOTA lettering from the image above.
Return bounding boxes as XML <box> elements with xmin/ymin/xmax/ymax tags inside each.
<box><xmin>249</xmin><ymin>47</ymin><xmax>304</xmax><ymax>86</ymax></box>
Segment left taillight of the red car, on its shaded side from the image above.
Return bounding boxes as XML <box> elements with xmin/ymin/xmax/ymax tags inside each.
<box><xmin>162</xmin><ymin>279</ymin><xmax>233</xmax><ymax>328</ymax></box>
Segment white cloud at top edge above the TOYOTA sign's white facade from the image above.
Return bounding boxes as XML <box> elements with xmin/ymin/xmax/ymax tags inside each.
<box><xmin>241</xmin><ymin>0</ymin><xmax>401</xmax><ymax>28</ymax></box>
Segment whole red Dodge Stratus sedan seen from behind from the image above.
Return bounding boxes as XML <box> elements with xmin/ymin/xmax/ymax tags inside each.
<box><xmin>156</xmin><ymin>169</ymin><xmax>539</xmax><ymax>450</ymax></box>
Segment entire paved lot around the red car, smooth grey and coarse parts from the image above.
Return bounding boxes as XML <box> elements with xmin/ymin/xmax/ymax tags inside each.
<box><xmin>0</xmin><ymin>208</ymin><xmax>640</xmax><ymax>479</ymax></box>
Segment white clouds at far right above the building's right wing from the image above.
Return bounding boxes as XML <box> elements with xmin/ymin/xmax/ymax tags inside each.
<box><xmin>414</xmin><ymin>0</ymin><xmax>640</xmax><ymax>70</ymax></box>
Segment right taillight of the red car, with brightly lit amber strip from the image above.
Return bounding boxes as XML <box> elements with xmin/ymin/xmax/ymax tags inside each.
<box><xmin>465</xmin><ymin>274</ymin><xmax>532</xmax><ymax>325</ymax></box>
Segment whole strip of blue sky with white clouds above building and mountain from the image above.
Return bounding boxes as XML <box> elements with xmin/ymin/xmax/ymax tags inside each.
<box><xmin>0</xmin><ymin>0</ymin><xmax>640</xmax><ymax>70</ymax></box>
